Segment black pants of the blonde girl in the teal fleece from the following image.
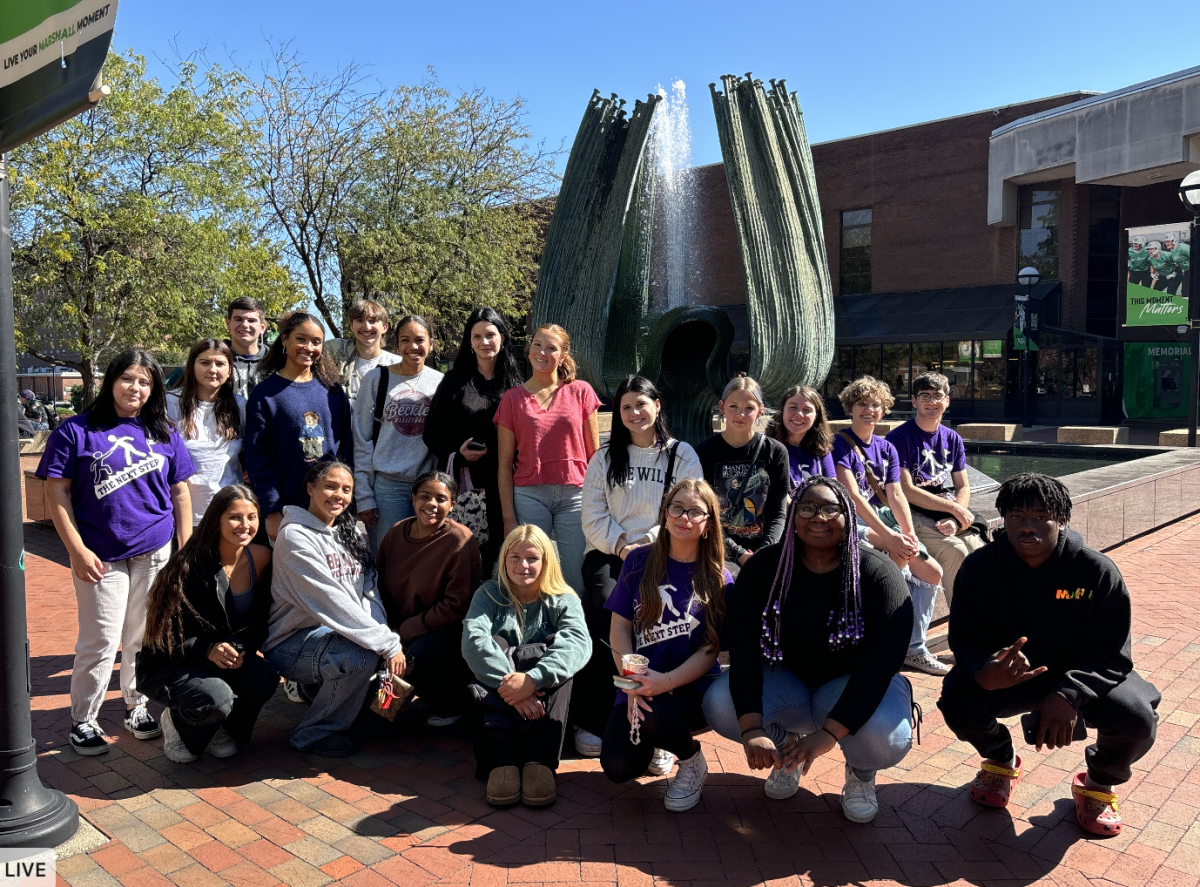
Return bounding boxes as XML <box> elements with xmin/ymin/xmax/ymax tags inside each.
<box><xmin>473</xmin><ymin>681</ymin><xmax>571</xmax><ymax>780</ymax></box>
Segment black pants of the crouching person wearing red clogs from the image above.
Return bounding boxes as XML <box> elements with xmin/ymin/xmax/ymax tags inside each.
<box><xmin>937</xmin><ymin>669</ymin><xmax>1162</xmax><ymax>785</ymax></box>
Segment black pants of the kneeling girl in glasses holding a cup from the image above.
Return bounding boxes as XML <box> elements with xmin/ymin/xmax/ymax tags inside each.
<box><xmin>600</xmin><ymin>682</ymin><xmax>709</xmax><ymax>783</ymax></box>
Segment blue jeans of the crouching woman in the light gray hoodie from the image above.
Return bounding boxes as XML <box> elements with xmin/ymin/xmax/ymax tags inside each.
<box><xmin>264</xmin><ymin>625</ymin><xmax>379</xmax><ymax>751</ymax></box>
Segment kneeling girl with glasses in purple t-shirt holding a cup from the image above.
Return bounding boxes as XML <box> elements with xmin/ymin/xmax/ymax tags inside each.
<box><xmin>600</xmin><ymin>478</ymin><xmax>733</xmax><ymax>813</ymax></box>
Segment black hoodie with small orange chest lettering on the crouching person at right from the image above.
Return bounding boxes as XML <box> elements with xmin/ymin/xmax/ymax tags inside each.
<box><xmin>950</xmin><ymin>528</ymin><xmax>1133</xmax><ymax>709</ymax></box>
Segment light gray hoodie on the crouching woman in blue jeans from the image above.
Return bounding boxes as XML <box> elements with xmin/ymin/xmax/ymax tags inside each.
<box><xmin>263</xmin><ymin>505</ymin><xmax>400</xmax><ymax>659</ymax></box>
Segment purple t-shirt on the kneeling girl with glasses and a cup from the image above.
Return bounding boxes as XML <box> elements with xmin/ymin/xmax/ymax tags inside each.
<box><xmin>605</xmin><ymin>545</ymin><xmax>733</xmax><ymax>705</ymax></box>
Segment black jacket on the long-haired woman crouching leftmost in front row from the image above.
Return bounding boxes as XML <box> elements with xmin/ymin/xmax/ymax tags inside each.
<box><xmin>138</xmin><ymin>557</ymin><xmax>271</xmax><ymax>667</ymax></box>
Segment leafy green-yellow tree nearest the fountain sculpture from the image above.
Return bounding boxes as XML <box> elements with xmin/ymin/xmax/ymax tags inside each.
<box><xmin>336</xmin><ymin>71</ymin><xmax>557</xmax><ymax>344</ymax></box>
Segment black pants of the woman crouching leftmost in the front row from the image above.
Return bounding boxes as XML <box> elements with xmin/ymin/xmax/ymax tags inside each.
<box><xmin>138</xmin><ymin>654</ymin><xmax>280</xmax><ymax>755</ymax></box>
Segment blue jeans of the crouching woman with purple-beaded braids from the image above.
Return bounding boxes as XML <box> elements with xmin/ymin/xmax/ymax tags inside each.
<box><xmin>702</xmin><ymin>663</ymin><xmax>912</xmax><ymax>779</ymax></box>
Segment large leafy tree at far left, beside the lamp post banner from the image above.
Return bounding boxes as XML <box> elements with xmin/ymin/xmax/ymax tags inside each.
<box><xmin>12</xmin><ymin>52</ymin><xmax>298</xmax><ymax>401</ymax></box>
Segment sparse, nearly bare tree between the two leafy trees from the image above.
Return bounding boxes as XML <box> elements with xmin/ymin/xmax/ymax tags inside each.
<box><xmin>231</xmin><ymin>43</ymin><xmax>380</xmax><ymax>336</ymax></box>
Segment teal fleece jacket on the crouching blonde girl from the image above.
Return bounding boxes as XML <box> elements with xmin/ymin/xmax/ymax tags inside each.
<box><xmin>462</xmin><ymin>580</ymin><xmax>592</xmax><ymax>690</ymax></box>
